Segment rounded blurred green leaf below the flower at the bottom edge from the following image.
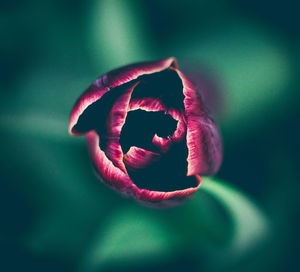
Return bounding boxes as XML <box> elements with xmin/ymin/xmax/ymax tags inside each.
<box><xmin>82</xmin><ymin>207</ymin><xmax>177</xmax><ymax>271</ymax></box>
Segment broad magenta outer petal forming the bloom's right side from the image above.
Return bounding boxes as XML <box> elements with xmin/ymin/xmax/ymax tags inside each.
<box><xmin>174</xmin><ymin>69</ymin><xmax>222</xmax><ymax>176</ymax></box>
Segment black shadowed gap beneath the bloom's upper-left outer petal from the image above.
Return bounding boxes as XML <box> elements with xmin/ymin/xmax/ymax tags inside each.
<box><xmin>72</xmin><ymin>70</ymin><xmax>184</xmax><ymax>135</ymax></box>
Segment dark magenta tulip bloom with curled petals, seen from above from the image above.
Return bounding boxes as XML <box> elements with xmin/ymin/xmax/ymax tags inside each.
<box><xmin>69</xmin><ymin>58</ymin><xmax>222</xmax><ymax>206</ymax></box>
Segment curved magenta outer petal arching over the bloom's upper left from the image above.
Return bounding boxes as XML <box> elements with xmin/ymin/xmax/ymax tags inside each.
<box><xmin>69</xmin><ymin>58</ymin><xmax>177</xmax><ymax>135</ymax></box>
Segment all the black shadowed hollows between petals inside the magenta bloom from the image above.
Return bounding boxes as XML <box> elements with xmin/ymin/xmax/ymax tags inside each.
<box><xmin>74</xmin><ymin>67</ymin><xmax>198</xmax><ymax>192</ymax></box>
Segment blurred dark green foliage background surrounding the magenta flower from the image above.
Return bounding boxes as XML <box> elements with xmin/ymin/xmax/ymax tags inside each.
<box><xmin>0</xmin><ymin>0</ymin><xmax>300</xmax><ymax>272</ymax></box>
